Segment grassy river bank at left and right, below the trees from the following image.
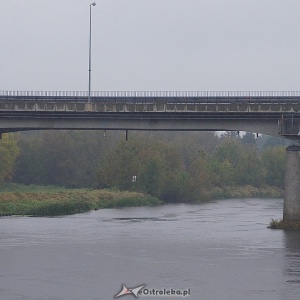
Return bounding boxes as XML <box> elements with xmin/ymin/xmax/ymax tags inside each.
<box><xmin>0</xmin><ymin>184</ymin><xmax>283</xmax><ymax>217</ymax></box>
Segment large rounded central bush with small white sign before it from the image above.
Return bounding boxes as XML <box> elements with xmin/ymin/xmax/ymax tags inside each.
<box><xmin>98</xmin><ymin>138</ymin><xmax>188</xmax><ymax>201</ymax></box>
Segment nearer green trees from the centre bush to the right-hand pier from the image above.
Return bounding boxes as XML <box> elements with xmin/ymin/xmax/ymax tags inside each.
<box><xmin>98</xmin><ymin>134</ymin><xmax>285</xmax><ymax>202</ymax></box>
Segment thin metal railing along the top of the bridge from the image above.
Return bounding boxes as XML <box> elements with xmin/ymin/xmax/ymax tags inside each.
<box><xmin>0</xmin><ymin>91</ymin><xmax>300</xmax><ymax>98</ymax></box>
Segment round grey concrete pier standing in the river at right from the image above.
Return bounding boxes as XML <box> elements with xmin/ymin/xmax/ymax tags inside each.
<box><xmin>283</xmin><ymin>146</ymin><xmax>300</xmax><ymax>222</ymax></box>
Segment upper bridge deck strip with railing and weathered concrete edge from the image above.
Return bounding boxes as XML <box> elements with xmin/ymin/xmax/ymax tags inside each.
<box><xmin>0</xmin><ymin>92</ymin><xmax>300</xmax><ymax>113</ymax></box>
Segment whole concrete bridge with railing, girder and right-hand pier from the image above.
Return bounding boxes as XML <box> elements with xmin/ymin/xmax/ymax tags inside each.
<box><xmin>0</xmin><ymin>91</ymin><xmax>300</xmax><ymax>222</ymax></box>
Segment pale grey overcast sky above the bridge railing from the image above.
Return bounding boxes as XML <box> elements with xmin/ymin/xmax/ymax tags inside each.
<box><xmin>0</xmin><ymin>0</ymin><xmax>300</xmax><ymax>91</ymax></box>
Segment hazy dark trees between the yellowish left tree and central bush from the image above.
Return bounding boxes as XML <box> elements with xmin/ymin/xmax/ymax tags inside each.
<box><xmin>14</xmin><ymin>130</ymin><xmax>117</xmax><ymax>187</ymax></box>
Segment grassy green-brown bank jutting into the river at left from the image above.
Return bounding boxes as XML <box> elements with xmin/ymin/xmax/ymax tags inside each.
<box><xmin>0</xmin><ymin>184</ymin><xmax>162</xmax><ymax>216</ymax></box>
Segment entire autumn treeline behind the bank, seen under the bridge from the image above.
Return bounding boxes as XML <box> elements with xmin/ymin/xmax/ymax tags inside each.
<box><xmin>0</xmin><ymin>131</ymin><xmax>287</xmax><ymax>202</ymax></box>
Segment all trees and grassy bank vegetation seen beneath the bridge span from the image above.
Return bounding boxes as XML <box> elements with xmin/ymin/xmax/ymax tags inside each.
<box><xmin>0</xmin><ymin>131</ymin><xmax>287</xmax><ymax>215</ymax></box>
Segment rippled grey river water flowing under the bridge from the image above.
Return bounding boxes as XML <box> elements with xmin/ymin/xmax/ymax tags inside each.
<box><xmin>0</xmin><ymin>199</ymin><xmax>300</xmax><ymax>300</ymax></box>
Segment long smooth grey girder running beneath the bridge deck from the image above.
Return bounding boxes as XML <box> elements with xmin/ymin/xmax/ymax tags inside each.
<box><xmin>0</xmin><ymin>113</ymin><xmax>288</xmax><ymax>136</ymax></box>
